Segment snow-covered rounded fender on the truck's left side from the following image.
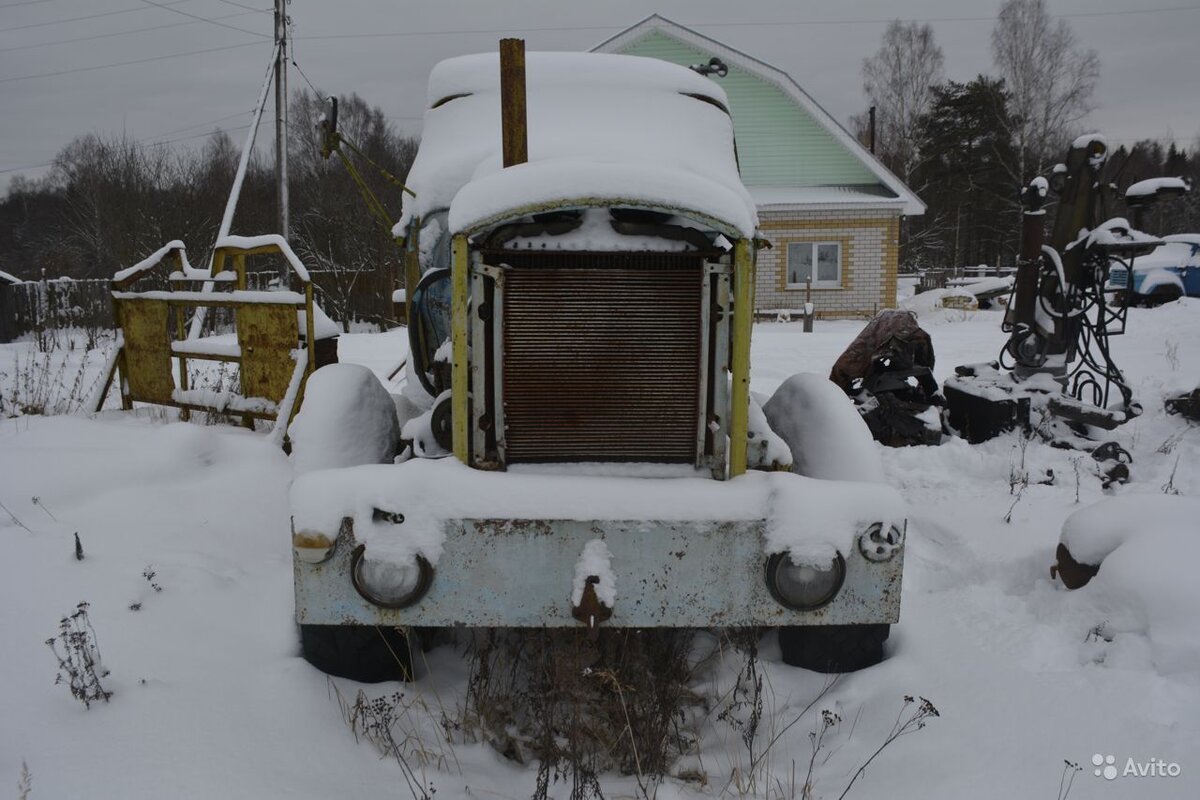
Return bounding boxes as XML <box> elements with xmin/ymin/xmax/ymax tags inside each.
<box><xmin>288</xmin><ymin>363</ymin><xmax>400</xmax><ymax>475</ymax></box>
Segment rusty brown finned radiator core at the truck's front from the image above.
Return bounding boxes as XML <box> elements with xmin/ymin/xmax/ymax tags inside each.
<box><xmin>503</xmin><ymin>253</ymin><xmax>703</xmax><ymax>463</ymax></box>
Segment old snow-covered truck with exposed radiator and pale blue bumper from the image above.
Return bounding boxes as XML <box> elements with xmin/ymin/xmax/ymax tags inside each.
<box><xmin>290</xmin><ymin>52</ymin><xmax>906</xmax><ymax>680</ymax></box>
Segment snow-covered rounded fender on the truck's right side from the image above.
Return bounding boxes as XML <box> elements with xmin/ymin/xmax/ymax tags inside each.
<box><xmin>762</xmin><ymin>372</ymin><xmax>884</xmax><ymax>483</ymax></box>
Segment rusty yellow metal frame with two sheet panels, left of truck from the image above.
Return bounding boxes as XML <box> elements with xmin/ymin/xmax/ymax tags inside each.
<box><xmin>100</xmin><ymin>243</ymin><xmax>316</xmax><ymax>439</ymax></box>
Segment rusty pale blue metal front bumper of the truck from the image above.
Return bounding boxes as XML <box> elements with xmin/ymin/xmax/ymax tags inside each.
<box><xmin>294</xmin><ymin>519</ymin><xmax>904</xmax><ymax>627</ymax></box>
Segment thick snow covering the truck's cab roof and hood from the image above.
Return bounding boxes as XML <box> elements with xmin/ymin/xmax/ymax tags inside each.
<box><xmin>394</xmin><ymin>53</ymin><xmax>757</xmax><ymax>236</ymax></box>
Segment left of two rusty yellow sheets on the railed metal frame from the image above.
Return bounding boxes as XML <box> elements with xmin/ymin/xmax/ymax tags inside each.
<box><xmin>113</xmin><ymin>300</ymin><xmax>175</xmax><ymax>404</ymax></box>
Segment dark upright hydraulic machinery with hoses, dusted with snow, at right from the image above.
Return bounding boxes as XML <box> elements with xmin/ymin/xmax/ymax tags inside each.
<box><xmin>944</xmin><ymin>134</ymin><xmax>1186</xmax><ymax>470</ymax></box>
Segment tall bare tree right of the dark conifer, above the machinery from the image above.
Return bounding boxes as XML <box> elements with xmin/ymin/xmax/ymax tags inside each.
<box><xmin>991</xmin><ymin>0</ymin><xmax>1100</xmax><ymax>176</ymax></box>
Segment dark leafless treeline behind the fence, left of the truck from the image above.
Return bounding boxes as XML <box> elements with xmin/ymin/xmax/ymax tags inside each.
<box><xmin>0</xmin><ymin>92</ymin><xmax>416</xmax><ymax>293</ymax></box>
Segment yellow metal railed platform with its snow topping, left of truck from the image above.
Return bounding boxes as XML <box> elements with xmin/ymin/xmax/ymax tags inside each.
<box><xmin>94</xmin><ymin>235</ymin><xmax>338</xmax><ymax>444</ymax></box>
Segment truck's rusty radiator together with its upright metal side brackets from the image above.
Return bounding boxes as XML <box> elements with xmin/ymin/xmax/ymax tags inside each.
<box><xmin>472</xmin><ymin>251</ymin><xmax>728</xmax><ymax>477</ymax></box>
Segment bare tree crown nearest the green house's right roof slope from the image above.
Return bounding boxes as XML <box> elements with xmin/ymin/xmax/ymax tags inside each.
<box><xmin>863</xmin><ymin>19</ymin><xmax>944</xmax><ymax>182</ymax></box>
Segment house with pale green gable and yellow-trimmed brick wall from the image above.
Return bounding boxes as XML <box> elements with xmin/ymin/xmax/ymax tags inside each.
<box><xmin>593</xmin><ymin>14</ymin><xmax>925</xmax><ymax>318</ymax></box>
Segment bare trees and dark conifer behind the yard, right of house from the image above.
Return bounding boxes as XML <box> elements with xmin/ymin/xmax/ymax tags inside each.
<box><xmin>852</xmin><ymin>0</ymin><xmax>1200</xmax><ymax>270</ymax></box>
